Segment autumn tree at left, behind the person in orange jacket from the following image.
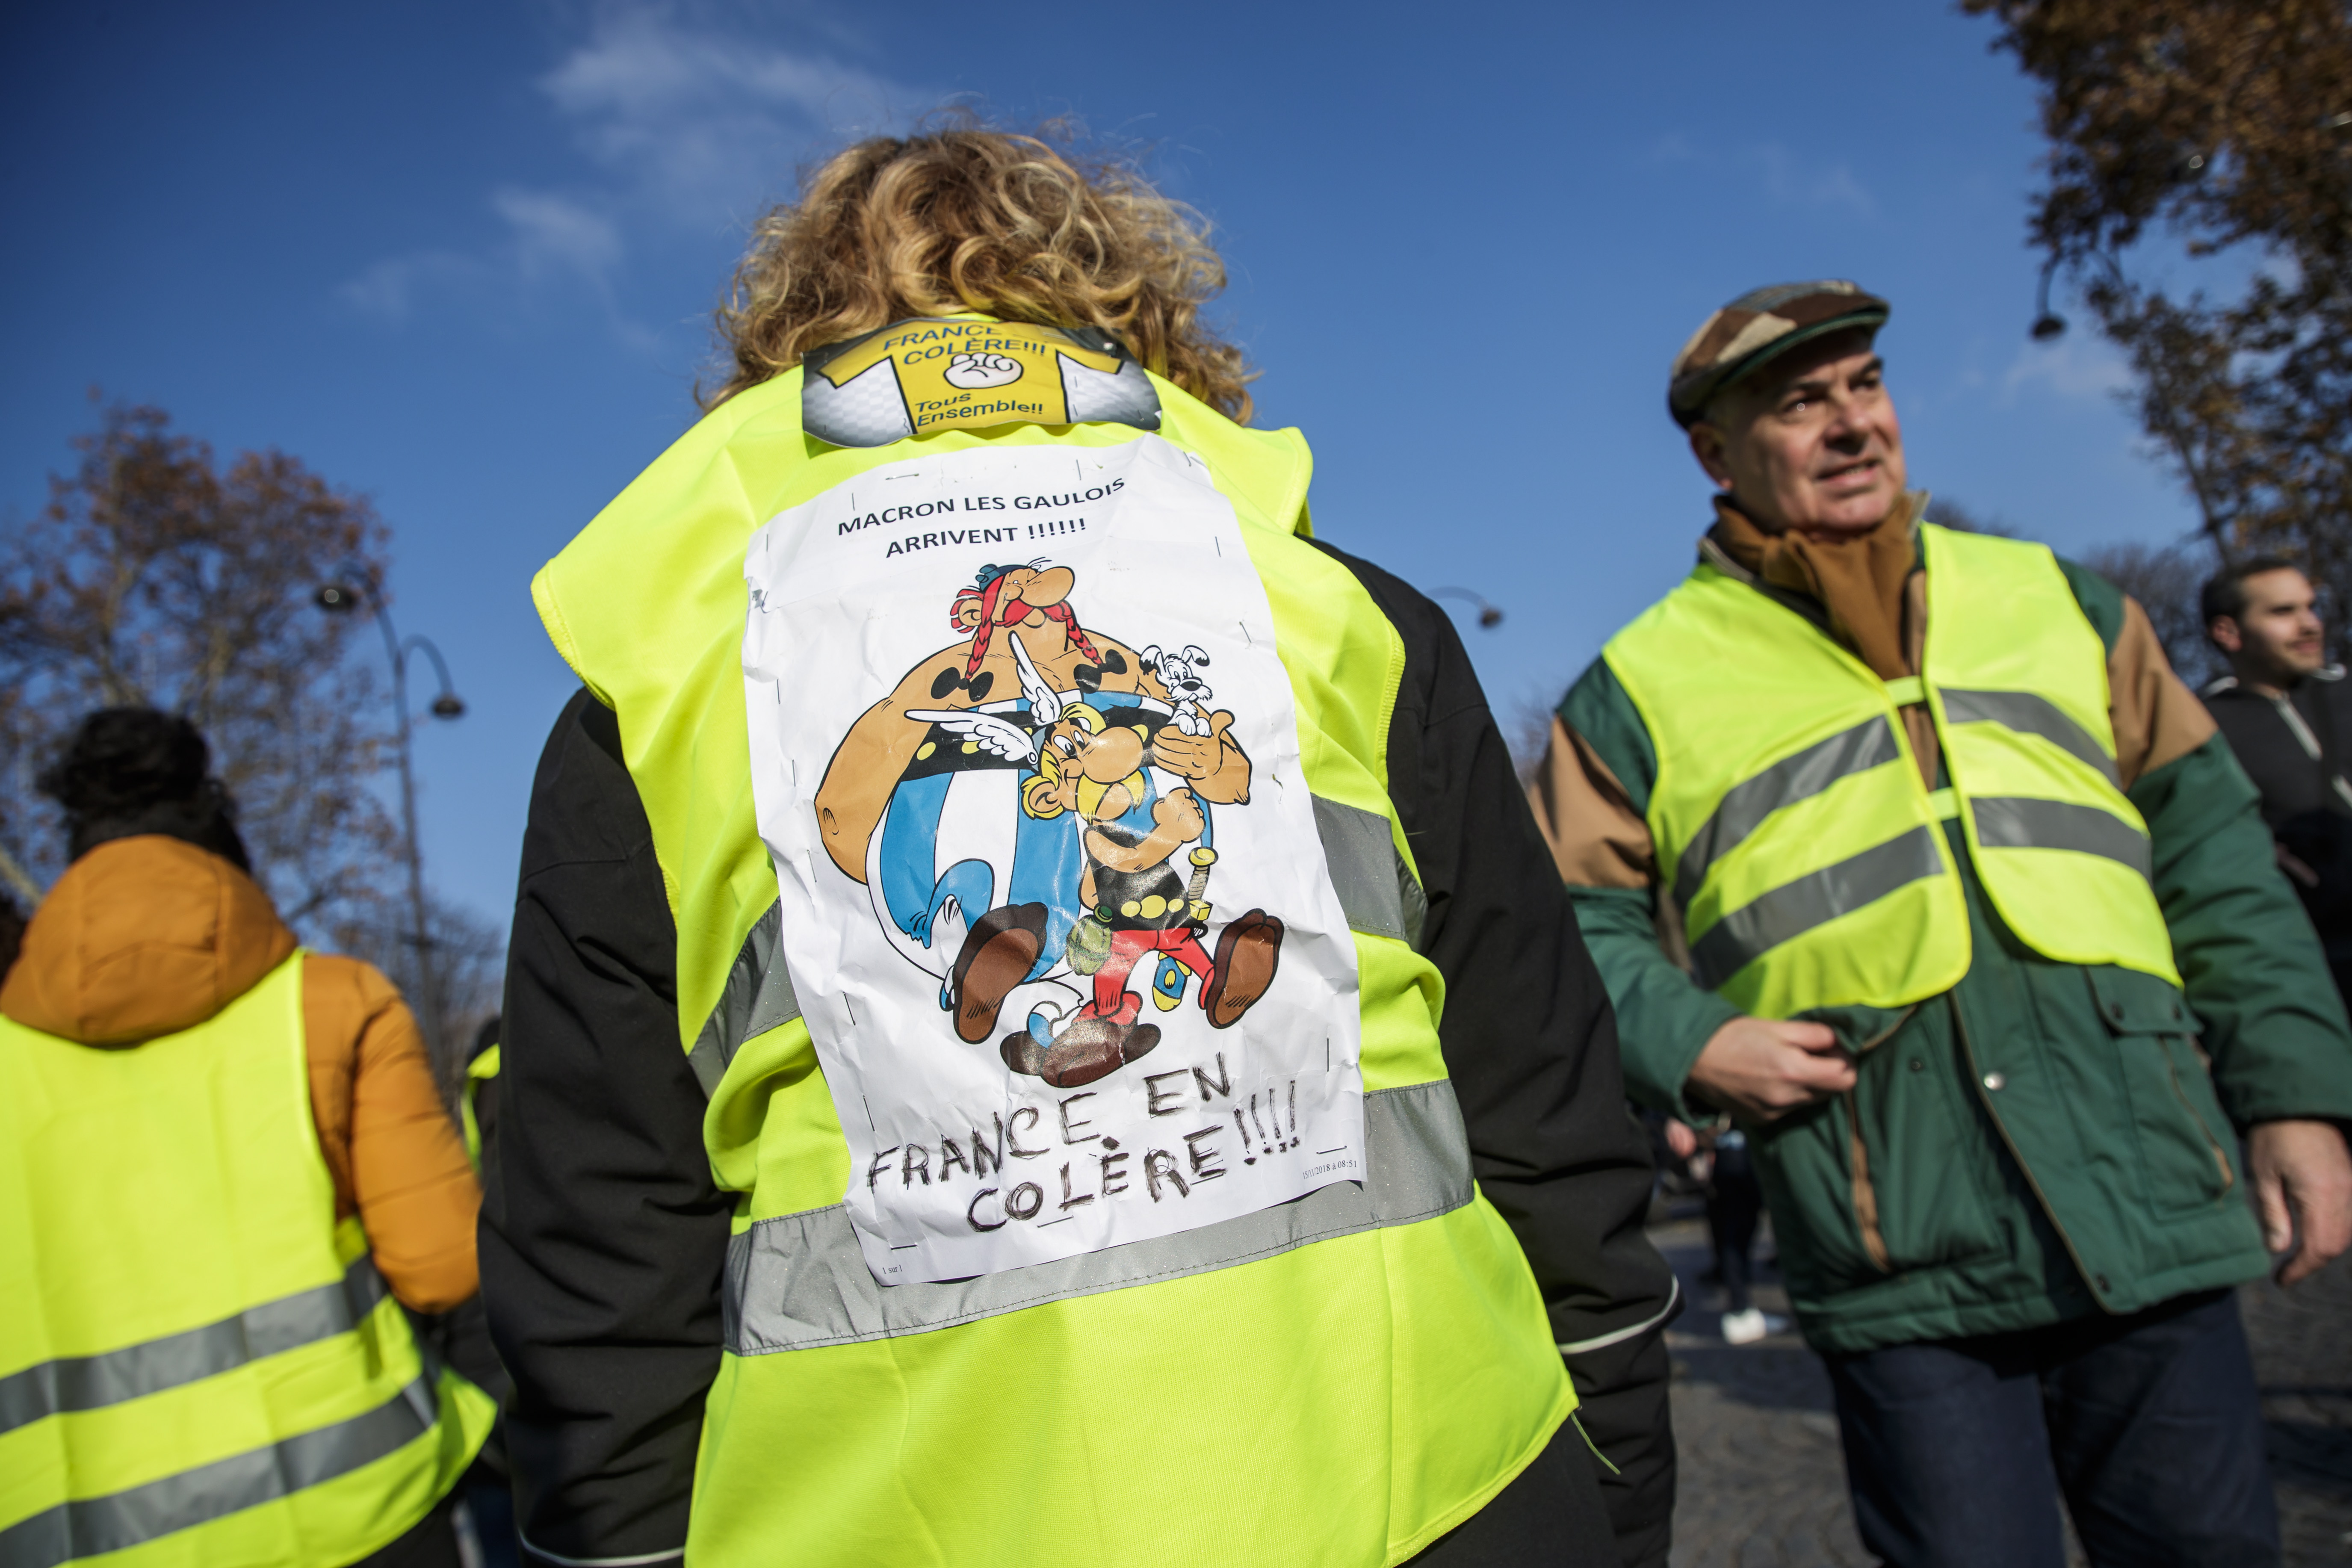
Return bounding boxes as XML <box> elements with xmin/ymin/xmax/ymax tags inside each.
<box><xmin>0</xmin><ymin>407</ymin><xmax>400</xmax><ymax>940</ymax></box>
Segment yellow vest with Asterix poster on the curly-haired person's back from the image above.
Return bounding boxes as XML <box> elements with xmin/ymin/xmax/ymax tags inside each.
<box><xmin>534</xmin><ymin>317</ymin><xmax>1576</xmax><ymax>1568</ymax></box>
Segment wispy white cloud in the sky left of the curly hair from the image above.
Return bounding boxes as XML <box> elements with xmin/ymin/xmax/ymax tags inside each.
<box><xmin>339</xmin><ymin>5</ymin><xmax>929</xmax><ymax>339</ymax></box>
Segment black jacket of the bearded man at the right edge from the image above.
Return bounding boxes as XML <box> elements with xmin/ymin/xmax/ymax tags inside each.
<box><xmin>2201</xmin><ymin>667</ymin><xmax>2352</xmax><ymax>964</ymax></box>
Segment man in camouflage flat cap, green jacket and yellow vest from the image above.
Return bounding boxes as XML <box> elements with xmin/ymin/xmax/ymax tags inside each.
<box><xmin>1531</xmin><ymin>282</ymin><xmax>2352</xmax><ymax>1568</ymax></box>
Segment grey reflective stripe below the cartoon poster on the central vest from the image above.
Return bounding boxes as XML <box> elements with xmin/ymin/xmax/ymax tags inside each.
<box><xmin>722</xmin><ymin>1079</ymin><xmax>1477</xmax><ymax>1356</ymax></box>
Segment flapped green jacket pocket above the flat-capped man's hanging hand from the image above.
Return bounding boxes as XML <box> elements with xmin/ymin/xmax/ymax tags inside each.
<box><xmin>2084</xmin><ymin>969</ymin><xmax>2237</xmax><ymax>1213</ymax></box>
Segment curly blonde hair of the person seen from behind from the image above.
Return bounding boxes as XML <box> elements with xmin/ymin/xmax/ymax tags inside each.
<box><xmin>699</xmin><ymin>124</ymin><xmax>1256</xmax><ymax>425</ymax></box>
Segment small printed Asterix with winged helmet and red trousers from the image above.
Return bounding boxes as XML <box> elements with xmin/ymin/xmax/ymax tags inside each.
<box><xmin>1002</xmin><ymin>703</ymin><xmax>1284</xmax><ymax>1088</ymax></box>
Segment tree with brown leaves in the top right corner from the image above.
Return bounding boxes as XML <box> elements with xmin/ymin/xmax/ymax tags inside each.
<box><xmin>1962</xmin><ymin>0</ymin><xmax>2352</xmax><ymax>649</ymax></box>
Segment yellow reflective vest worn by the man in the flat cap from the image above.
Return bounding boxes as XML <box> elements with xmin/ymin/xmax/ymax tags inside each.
<box><xmin>1604</xmin><ymin>524</ymin><xmax>2178</xmax><ymax>1018</ymax></box>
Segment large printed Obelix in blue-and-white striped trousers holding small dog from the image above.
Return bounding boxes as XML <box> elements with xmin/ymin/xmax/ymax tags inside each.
<box><xmin>816</xmin><ymin>562</ymin><xmax>1249</xmax><ymax>1044</ymax></box>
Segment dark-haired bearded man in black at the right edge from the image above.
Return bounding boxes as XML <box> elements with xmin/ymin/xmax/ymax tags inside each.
<box><xmin>2199</xmin><ymin>555</ymin><xmax>2352</xmax><ymax>995</ymax></box>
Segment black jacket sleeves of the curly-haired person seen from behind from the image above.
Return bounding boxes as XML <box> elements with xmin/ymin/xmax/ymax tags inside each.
<box><xmin>482</xmin><ymin>550</ymin><xmax>1677</xmax><ymax>1563</ymax></box>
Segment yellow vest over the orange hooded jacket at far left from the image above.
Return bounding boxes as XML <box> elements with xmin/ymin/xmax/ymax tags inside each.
<box><xmin>0</xmin><ymin>952</ymin><xmax>494</xmax><ymax>1568</ymax></box>
